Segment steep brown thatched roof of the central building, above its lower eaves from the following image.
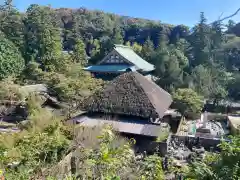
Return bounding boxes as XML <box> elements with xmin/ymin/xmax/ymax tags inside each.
<box><xmin>83</xmin><ymin>72</ymin><xmax>172</xmax><ymax>118</ymax></box>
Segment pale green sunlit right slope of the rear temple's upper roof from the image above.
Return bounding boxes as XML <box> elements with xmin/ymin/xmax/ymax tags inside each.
<box><xmin>114</xmin><ymin>45</ymin><xmax>154</xmax><ymax>71</ymax></box>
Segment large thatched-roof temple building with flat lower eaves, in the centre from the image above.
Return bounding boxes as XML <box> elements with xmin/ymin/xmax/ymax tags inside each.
<box><xmin>69</xmin><ymin>72</ymin><xmax>172</xmax><ymax>153</ymax></box>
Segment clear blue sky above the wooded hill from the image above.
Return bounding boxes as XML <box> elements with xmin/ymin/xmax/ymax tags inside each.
<box><xmin>12</xmin><ymin>0</ymin><xmax>240</xmax><ymax>26</ymax></box>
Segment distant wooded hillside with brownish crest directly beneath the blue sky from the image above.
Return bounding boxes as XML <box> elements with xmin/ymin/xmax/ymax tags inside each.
<box><xmin>56</xmin><ymin>8</ymin><xmax>189</xmax><ymax>52</ymax></box>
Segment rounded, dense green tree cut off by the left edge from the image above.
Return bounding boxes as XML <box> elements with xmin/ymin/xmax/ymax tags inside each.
<box><xmin>0</xmin><ymin>32</ymin><xmax>24</xmax><ymax>79</ymax></box>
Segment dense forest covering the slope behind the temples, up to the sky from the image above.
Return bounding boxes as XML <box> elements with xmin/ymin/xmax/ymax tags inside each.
<box><xmin>0</xmin><ymin>1</ymin><xmax>240</xmax><ymax>100</ymax></box>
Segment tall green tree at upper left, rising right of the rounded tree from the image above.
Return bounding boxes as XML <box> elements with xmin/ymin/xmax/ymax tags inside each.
<box><xmin>25</xmin><ymin>5</ymin><xmax>62</xmax><ymax>70</ymax></box>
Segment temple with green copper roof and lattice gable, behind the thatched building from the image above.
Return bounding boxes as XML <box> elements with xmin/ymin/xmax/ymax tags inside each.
<box><xmin>84</xmin><ymin>45</ymin><xmax>154</xmax><ymax>80</ymax></box>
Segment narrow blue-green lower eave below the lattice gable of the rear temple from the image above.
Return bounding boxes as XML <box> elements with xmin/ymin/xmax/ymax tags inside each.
<box><xmin>84</xmin><ymin>64</ymin><xmax>132</xmax><ymax>72</ymax></box>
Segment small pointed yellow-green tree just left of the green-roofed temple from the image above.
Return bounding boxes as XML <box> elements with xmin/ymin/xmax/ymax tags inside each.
<box><xmin>72</xmin><ymin>39</ymin><xmax>87</xmax><ymax>65</ymax></box>
